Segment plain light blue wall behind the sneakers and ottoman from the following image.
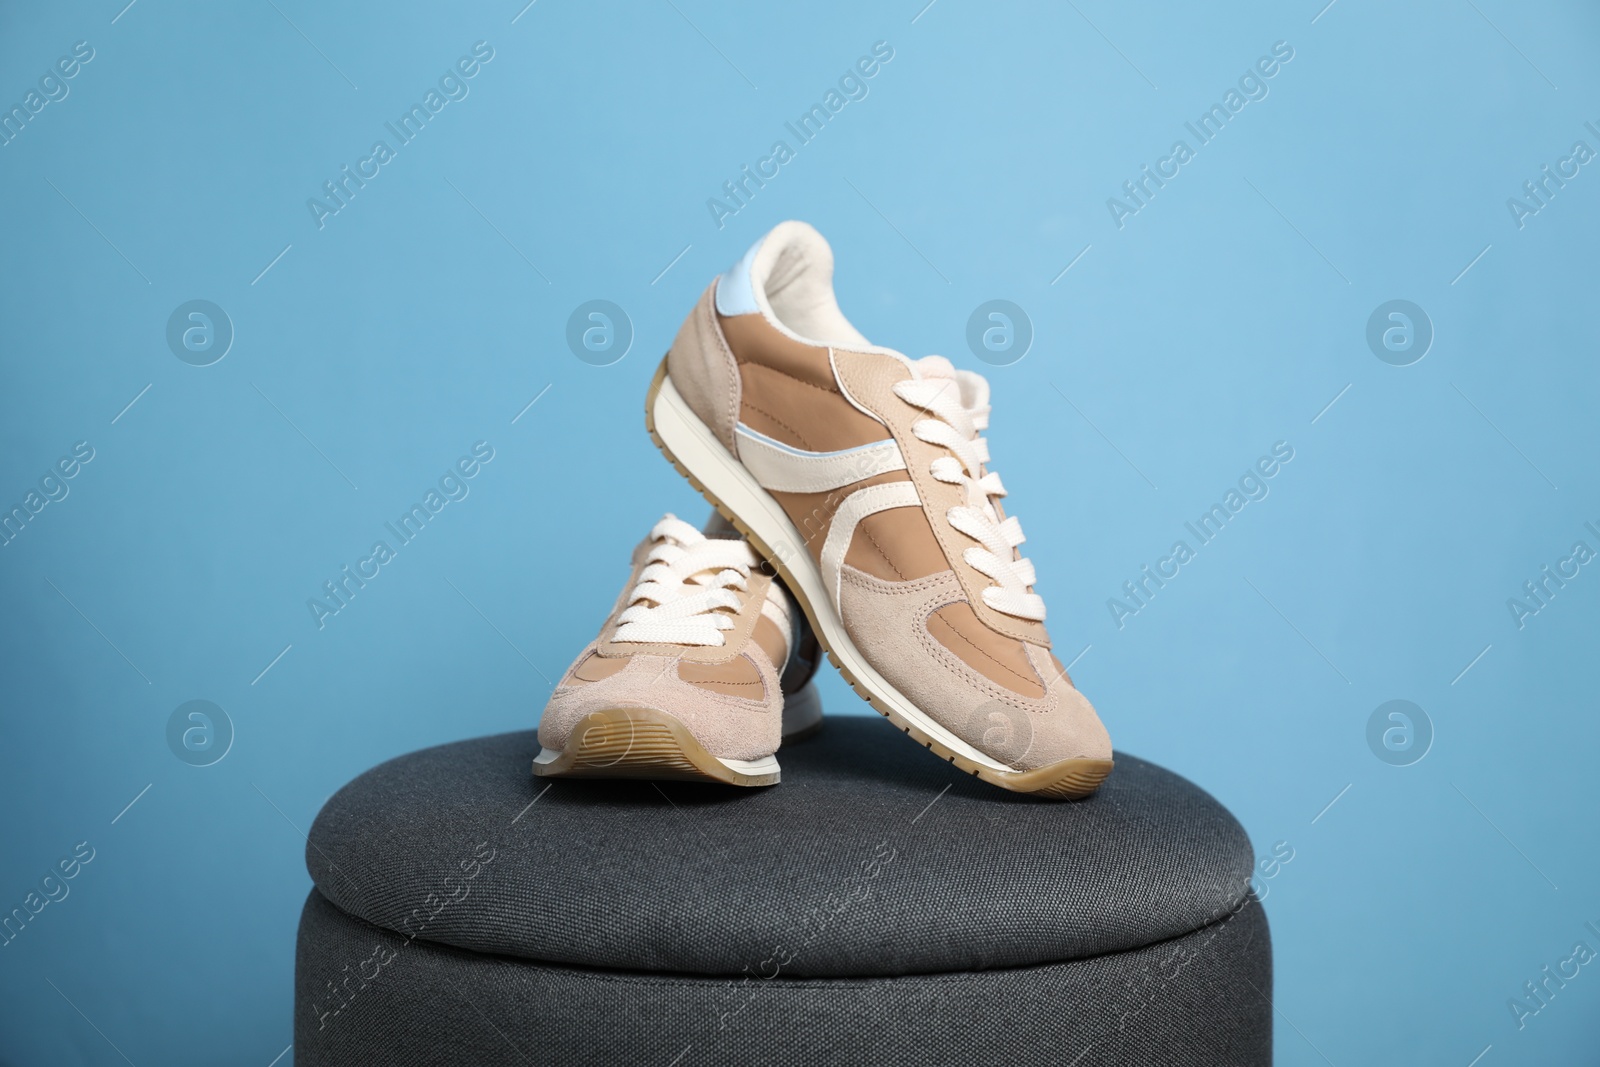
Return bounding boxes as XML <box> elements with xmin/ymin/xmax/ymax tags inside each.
<box><xmin>0</xmin><ymin>0</ymin><xmax>1600</xmax><ymax>1067</ymax></box>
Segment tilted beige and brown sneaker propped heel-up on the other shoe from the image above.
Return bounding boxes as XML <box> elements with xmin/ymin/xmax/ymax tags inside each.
<box><xmin>645</xmin><ymin>222</ymin><xmax>1112</xmax><ymax>797</ymax></box>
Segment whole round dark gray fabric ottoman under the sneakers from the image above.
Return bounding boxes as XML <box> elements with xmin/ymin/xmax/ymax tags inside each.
<box><xmin>294</xmin><ymin>718</ymin><xmax>1272</xmax><ymax>1067</ymax></box>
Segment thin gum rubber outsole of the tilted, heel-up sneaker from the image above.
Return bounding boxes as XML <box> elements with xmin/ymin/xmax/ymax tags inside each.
<box><xmin>645</xmin><ymin>357</ymin><xmax>1114</xmax><ymax>800</ymax></box>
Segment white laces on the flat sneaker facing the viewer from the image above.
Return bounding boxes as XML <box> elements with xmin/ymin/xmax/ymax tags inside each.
<box><xmin>611</xmin><ymin>515</ymin><xmax>789</xmax><ymax>646</ymax></box>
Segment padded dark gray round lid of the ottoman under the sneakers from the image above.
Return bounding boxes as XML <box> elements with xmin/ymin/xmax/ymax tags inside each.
<box><xmin>307</xmin><ymin>717</ymin><xmax>1251</xmax><ymax>977</ymax></box>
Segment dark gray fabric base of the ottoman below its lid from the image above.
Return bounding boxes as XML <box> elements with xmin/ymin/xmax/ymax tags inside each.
<box><xmin>294</xmin><ymin>889</ymin><xmax>1272</xmax><ymax>1067</ymax></box>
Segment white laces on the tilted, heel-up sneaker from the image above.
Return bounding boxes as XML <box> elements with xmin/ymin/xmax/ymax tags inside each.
<box><xmin>894</xmin><ymin>355</ymin><xmax>1045</xmax><ymax>622</ymax></box>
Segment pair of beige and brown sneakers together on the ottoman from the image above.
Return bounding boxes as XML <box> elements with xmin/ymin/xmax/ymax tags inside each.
<box><xmin>534</xmin><ymin>222</ymin><xmax>1112</xmax><ymax>798</ymax></box>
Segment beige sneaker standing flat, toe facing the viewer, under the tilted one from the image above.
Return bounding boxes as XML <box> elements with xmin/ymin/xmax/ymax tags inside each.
<box><xmin>533</xmin><ymin>515</ymin><xmax>822</xmax><ymax>785</ymax></box>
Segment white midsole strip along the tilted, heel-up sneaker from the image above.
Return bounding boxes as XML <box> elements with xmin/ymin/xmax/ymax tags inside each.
<box><xmin>651</xmin><ymin>376</ymin><xmax>1016</xmax><ymax>773</ymax></box>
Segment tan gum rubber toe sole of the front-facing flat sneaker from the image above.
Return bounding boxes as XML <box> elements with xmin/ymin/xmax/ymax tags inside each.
<box><xmin>533</xmin><ymin>707</ymin><xmax>779</xmax><ymax>785</ymax></box>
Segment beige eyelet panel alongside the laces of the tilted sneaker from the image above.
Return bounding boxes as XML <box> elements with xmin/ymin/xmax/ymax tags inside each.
<box><xmin>834</xmin><ymin>349</ymin><xmax>1050</xmax><ymax>648</ymax></box>
